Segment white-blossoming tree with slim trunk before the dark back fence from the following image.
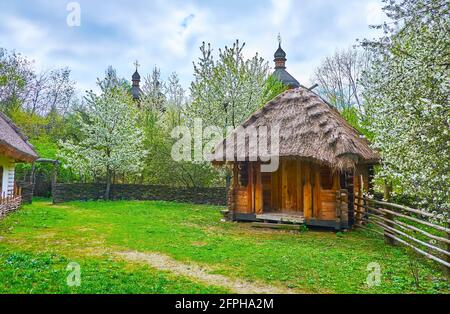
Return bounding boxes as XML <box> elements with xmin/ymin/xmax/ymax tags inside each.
<box><xmin>60</xmin><ymin>80</ymin><xmax>147</xmax><ymax>199</ymax></box>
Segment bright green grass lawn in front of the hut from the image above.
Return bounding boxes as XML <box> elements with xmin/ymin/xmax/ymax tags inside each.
<box><xmin>0</xmin><ymin>200</ymin><xmax>449</xmax><ymax>293</ymax></box>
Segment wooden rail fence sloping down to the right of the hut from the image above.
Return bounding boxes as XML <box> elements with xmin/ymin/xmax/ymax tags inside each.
<box><xmin>337</xmin><ymin>190</ymin><xmax>450</xmax><ymax>271</ymax></box>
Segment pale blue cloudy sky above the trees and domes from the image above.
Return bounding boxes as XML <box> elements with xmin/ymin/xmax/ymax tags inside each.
<box><xmin>0</xmin><ymin>0</ymin><xmax>384</xmax><ymax>92</ymax></box>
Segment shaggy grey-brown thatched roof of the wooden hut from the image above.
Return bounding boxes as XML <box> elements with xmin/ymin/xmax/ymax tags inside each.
<box><xmin>214</xmin><ymin>87</ymin><xmax>379</xmax><ymax>170</ymax></box>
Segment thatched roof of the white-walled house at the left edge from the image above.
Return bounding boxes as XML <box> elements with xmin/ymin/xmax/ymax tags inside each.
<box><xmin>0</xmin><ymin>112</ymin><xmax>38</xmax><ymax>162</ymax></box>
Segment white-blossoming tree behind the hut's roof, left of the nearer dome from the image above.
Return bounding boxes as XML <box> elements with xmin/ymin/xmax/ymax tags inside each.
<box><xmin>187</xmin><ymin>40</ymin><xmax>269</xmax><ymax>128</ymax></box>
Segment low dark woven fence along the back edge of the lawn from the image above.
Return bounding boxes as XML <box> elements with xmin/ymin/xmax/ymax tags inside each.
<box><xmin>53</xmin><ymin>183</ymin><xmax>227</xmax><ymax>206</ymax></box>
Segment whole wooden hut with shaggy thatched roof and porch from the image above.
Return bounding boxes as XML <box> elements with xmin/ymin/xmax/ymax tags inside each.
<box><xmin>214</xmin><ymin>87</ymin><xmax>379</xmax><ymax>229</ymax></box>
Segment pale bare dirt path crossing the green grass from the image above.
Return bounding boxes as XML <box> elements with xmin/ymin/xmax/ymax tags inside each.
<box><xmin>118</xmin><ymin>252</ymin><xmax>296</xmax><ymax>294</ymax></box>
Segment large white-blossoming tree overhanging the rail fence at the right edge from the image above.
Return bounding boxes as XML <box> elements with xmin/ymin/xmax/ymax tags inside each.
<box><xmin>363</xmin><ymin>0</ymin><xmax>450</xmax><ymax>213</ymax></box>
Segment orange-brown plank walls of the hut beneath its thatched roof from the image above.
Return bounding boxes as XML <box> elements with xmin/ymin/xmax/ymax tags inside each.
<box><xmin>230</xmin><ymin>159</ymin><xmax>360</xmax><ymax>220</ymax></box>
